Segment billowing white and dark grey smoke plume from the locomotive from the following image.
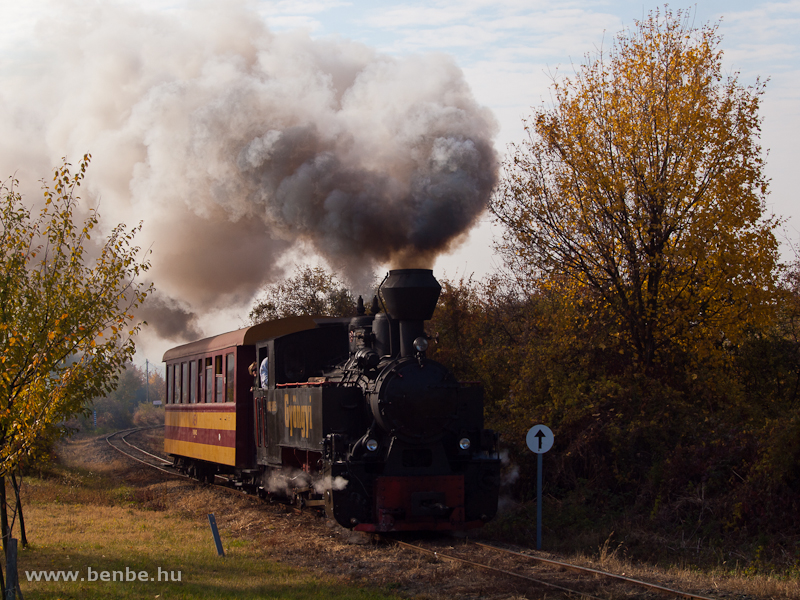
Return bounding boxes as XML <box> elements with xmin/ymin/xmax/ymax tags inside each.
<box><xmin>0</xmin><ymin>2</ymin><xmax>497</xmax><ymax>337</ymax></box>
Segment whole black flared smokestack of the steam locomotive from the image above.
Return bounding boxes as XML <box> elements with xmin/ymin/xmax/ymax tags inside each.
<box><xmin>381</xmin><ymin>269</ymin><xmax>442</xmax><ymax>356</ymax></box>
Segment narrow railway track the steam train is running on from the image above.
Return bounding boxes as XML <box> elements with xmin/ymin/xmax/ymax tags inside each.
<box><xmin>111</xmin><ymin>428</ymin><xmax>715</xmax><ymax>600</ymax></box>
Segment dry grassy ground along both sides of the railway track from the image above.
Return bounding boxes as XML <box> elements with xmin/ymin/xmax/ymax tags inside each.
<box><xmin>12</xmin><ymin>433</ymin><xmax>800</xmax><ymax>600</ymax></box>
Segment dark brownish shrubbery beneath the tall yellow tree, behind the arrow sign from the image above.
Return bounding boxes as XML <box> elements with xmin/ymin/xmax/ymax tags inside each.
<box><xmin>430</xmin><ymin>266</ymin><xmax>800</xmax><ymax>564</ymax></box>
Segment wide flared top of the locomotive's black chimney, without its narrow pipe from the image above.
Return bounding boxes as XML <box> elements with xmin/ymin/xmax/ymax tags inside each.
<box><xmin>381</xmin><ymin>269</ymin><xmax>442</xmax><ymax>321</ymax></box>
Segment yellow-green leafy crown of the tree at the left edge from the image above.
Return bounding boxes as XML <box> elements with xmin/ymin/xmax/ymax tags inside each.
<box><xmin>0</xmin><ymin>155</ymin><xmax>152</xmax><ymax>478</ymax></box>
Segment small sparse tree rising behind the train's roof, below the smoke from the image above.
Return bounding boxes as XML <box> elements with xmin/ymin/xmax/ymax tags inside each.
<box><xmin>250</xmin><ymin>267</ymin><xmax>356</xmax><ymax>325</ymax></box>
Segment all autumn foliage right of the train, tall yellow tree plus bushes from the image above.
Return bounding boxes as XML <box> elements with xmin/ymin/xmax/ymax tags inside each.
<box><xmin>424</xmin><ymin>9</ymin><xmax>800</xmax><ymax>555</ymax></box>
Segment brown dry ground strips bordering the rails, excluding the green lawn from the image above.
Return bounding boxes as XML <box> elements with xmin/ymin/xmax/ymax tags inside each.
<box><xmin>53</xmin><ymin>429</ymin><xmax>794</xmax><ymax>600</ymax></box>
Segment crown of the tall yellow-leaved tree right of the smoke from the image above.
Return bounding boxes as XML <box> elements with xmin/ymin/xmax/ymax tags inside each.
<box><xmin>491</xmin><ymin>8</ymin><xmax>779</xmax><ymax>370</ymax></box>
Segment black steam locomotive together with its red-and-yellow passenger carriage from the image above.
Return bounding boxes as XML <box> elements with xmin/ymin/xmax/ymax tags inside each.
<box><xmin>164</xmin><ymin>269</ymin><xmax>500</xmax><ymax>532</ymax></box>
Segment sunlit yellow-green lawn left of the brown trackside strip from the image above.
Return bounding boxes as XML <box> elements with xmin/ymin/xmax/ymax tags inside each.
<box><xmin>20</xmin><ymin>504</ymin><xmax>386</xmax><ymax>599</ymax></box>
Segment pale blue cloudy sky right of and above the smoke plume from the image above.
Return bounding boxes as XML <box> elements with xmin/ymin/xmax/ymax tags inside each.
<box><xmin>247</xmin><ymin>0</ymin><xmax>800</xmax><ymax>276</ymax></box>
